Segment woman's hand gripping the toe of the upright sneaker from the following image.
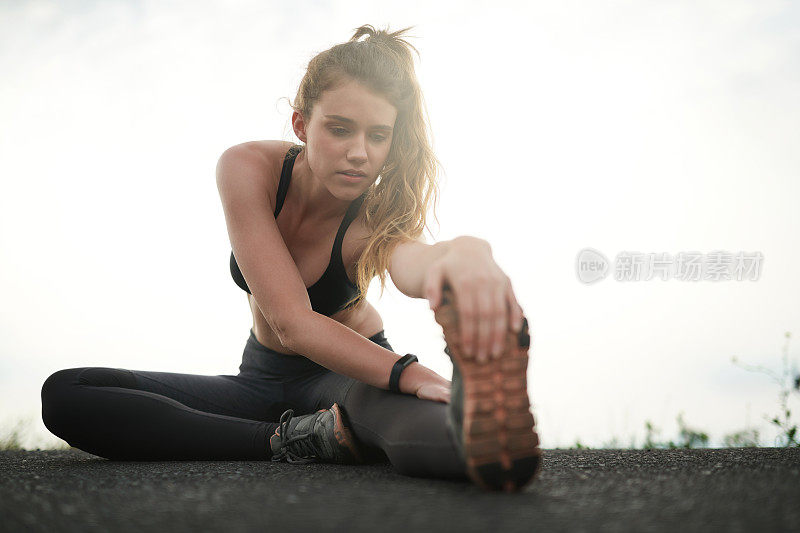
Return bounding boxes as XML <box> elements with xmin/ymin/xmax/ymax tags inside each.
<box><xmin>424</xmin><ymin>236</ymin><xmax>523</xmax><ymax>361</ymax></box>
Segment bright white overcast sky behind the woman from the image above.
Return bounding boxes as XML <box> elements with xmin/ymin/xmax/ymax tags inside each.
<box><xmin>0</xmin><ymin>0</ymin><xmax>800</xmax><ymax>447</ymax></box>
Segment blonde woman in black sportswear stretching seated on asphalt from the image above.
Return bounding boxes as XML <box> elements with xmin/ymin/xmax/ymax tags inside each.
<box><xmin>42</xmin><ymin>25</ymin><xmax>540</xmax><ymax>490</ymax></box>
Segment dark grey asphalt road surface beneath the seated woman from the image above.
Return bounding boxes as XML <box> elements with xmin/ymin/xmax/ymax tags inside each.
<box><xmin>0</xmin><ymin>448</ymin><xmax>800</xmax><ymax>533</ymax></box>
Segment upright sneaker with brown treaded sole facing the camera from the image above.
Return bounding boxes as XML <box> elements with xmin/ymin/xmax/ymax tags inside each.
<box><xmin>436</xmin><ymin>288</ymin><xmax>542</xmax><ymax>492</ymax></box>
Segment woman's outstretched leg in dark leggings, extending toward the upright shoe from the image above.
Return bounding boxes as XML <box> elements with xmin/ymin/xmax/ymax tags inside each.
<box><xmin>286</xmin><ymin>331</ymin><xmax>468</xmax><ymax>480</ymax></box>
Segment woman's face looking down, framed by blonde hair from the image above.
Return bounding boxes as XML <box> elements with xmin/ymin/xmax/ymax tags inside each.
<box><xmin>292</xmin><ymin>79</ymin><xmax>397</xmax><ymax>200</ymax></box>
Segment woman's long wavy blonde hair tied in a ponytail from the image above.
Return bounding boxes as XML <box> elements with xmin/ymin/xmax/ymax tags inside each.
<box><xmin>291</xmin><ymin>24</ymin><xmax>440</xmax><ymax>306</ymax></box>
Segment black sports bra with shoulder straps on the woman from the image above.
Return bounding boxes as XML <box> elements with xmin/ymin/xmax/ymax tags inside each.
<box><xmin>230</xmin><ymin>145</ymin><xmax>366</xmax><ymax>316</ymax></box>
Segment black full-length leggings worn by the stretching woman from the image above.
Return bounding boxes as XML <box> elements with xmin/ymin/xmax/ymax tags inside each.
<box><xmin>42</xmin><ymin>329</ymin><xmax>467</xmax><ymax>480</ymax></box>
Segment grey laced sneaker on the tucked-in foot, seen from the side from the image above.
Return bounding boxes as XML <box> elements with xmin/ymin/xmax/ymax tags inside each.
<box><xmin>269</xmin><ymin>404</ymin><xmax>361</xmax><ymax>464</ymax></box>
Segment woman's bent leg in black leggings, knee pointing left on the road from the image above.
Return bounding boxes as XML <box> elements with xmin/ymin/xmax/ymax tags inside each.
<box><xmin>42</xmin><ymin>367</ymin><xmax>285</xmax><ymax>460</ymax></box>
